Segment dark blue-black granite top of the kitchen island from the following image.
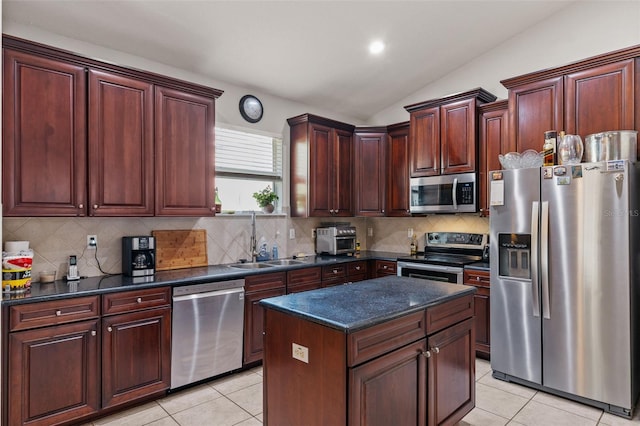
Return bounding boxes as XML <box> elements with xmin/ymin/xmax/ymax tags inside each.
<box><xmin>259</xmin><ymin>276</ymin><xmax>476</xmax><ymax>333</ymax></box>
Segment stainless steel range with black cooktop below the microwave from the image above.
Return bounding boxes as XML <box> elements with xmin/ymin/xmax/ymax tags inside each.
<box><xmin>398</xmin><ymin>232</ymin><xmax>489</xmax><ymax>284</ymax></box>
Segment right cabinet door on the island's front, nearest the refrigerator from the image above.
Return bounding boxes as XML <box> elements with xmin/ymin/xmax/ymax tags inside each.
<box><xmin>427</xmin><ymin>318</ymin><xmax>476</xmax><ymax>426</ymax></box>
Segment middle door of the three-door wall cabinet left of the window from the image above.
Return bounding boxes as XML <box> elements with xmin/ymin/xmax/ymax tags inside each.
<box><xmin>89</xmin><ymin>70</ymin><xmax>154</xmax><ymax>216</ymax></box>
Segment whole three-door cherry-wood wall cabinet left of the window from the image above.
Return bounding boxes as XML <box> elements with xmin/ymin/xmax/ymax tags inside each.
<box><xmin>2</xmin><ymin>35</ymin><xmax>222</xmax><ymax>216</ymax></box>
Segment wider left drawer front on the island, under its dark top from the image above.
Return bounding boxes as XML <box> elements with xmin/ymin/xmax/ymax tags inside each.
<box><xmin>347</xmin><ymin>310</ymin><xmax>427</xmax><ymax>367</ymax></box>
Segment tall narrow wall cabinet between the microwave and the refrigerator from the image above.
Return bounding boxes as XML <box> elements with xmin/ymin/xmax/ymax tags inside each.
<box><xmin>478</xmin><ymin>100</ymin><xmax>509</xmax><ymax>216</ymax></box>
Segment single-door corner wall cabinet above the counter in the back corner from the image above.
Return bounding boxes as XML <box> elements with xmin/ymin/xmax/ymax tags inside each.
<box><xmin>354</xmin><ymin>127</ymin><xmax>387</xmax><ymax>216</ymax></box>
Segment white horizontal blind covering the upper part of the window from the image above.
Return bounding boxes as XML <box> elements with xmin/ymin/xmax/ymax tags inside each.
<box><xmin>216</xmin><ymin>128</ymin><xmax>282</xmax><ymax>179</ymax></box>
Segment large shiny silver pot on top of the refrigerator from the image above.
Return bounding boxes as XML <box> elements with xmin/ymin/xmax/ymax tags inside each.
<box><xmin>585</xmin><ymin>130</ymin><xmax>638</xmax><ymax>163</ymax></box>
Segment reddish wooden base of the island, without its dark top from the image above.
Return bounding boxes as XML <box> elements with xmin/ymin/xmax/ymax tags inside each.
<box><xmin>264</xmin><ymin>295</ymin><xmax>475</xmax><ymax>426</ymax></box>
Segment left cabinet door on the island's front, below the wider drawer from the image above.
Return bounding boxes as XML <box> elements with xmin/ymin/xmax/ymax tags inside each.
<box><xmin>348</xmin><ymin>339</ymin><xmax>427</xmax><ymax>426</ymax></box>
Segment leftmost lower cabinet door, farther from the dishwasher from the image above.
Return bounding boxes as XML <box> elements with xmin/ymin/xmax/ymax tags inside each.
<box><xmin>7</xmin><ymin>319</ymin><xmax>100</xmax><ymax>426</ymax></box>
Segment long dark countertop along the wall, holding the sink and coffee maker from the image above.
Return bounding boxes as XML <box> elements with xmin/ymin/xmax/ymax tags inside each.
<box><xmin>2</xmin><ymin>251</ymin><xmax>404</xmax><ymax>306</ymax></box>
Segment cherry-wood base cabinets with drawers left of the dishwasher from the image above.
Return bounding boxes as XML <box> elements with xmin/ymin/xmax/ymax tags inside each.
<box><xmin>2</xmin><ymin>287</ymin><xmax>171</xmax><ymax>426</ymax></box>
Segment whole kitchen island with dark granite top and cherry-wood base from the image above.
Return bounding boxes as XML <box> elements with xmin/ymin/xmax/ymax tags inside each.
<box><xmin>260</xmin><ymin>276</ymin><xmax>475</xmax><ymax>426</ymax></box>
